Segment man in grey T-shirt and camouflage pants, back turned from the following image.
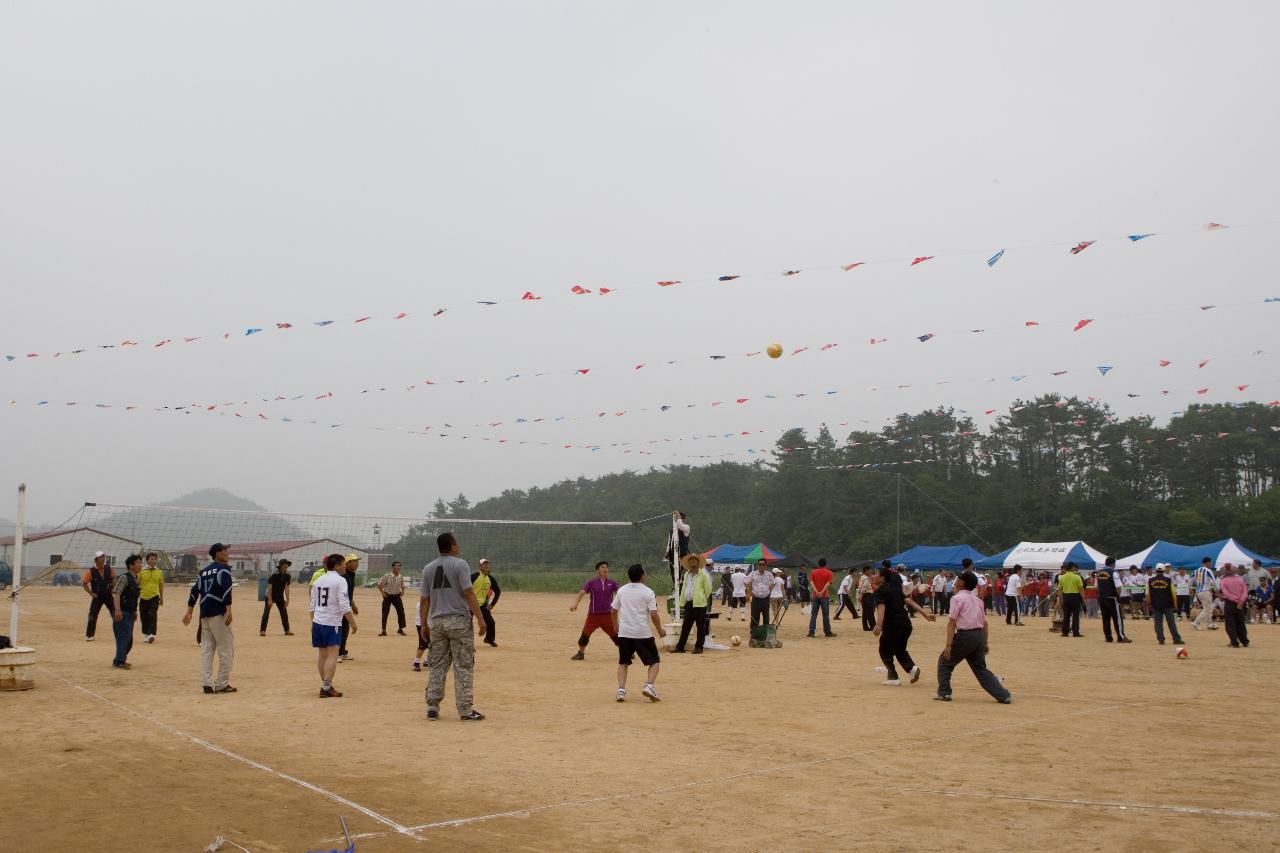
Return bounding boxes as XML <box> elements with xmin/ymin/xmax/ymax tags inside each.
<box><xmin>419</xmin><ymin>533</ymin><xmax>484</xmax><ymax>720</ymax></box>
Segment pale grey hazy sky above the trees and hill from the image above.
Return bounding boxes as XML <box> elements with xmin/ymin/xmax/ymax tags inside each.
<box><xmin>0</xmin><ymin>0</ymin><xmax>1280</xmax><ymax>523</ymax></box>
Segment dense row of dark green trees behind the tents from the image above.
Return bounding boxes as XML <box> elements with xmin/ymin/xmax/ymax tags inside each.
<box><xmin>401</xmin><ymin>394</ymin><xmax>1280</xmax><ymax>562</ymax></box>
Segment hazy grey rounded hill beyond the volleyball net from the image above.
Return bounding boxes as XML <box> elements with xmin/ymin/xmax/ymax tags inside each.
<box><xmin>88</xmin><ymin>488</ymin><xmax>314</xmax><ymax>551</ymax></box>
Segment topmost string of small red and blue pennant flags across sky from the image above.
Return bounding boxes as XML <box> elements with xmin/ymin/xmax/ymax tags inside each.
<box><xmin>4</xmin><ymin>222</ymin><xmax>1280</xmax><ymax>363</ymax></box>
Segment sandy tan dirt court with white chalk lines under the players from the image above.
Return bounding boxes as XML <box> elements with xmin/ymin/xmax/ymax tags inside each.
<box><xmin>0</xmin><ymin>584</ymin><xmax>1280</xmax><ymax>853</ymax></box>
